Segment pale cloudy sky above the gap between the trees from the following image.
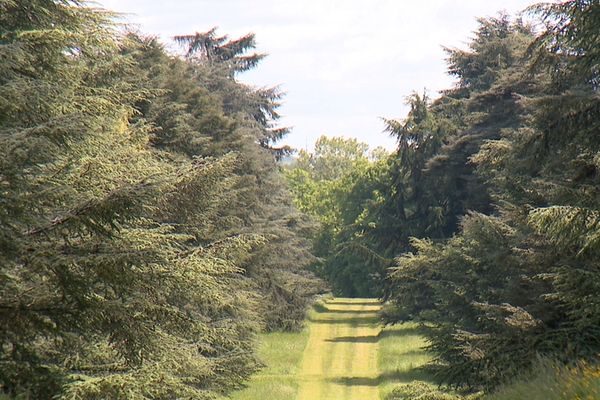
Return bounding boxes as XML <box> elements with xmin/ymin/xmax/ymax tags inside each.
<box><xmin>97</xmin><ymin>0</ymin><xmax>536</xmax><ymax>150</ymax></box>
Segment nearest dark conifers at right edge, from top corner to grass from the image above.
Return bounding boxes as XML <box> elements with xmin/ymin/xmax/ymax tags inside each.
<box><xmin>389</xmin><ymin>1</ymin><xmax>600</xmax><ymax>389</ymax></box>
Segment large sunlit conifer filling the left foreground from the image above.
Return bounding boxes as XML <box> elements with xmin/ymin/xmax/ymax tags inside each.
<box><xmin>0</xmin><ymin>0</ymin><xmax>264</xmax><ymax>399</ymax></box>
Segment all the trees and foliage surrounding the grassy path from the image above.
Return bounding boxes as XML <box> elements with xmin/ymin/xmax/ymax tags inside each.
<box><xmin>0</xmin><ymin>0</ymin><xmax>600</xmax><ymax>399</ymax></box>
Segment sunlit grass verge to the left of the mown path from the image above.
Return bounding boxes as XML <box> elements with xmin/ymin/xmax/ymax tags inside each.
<box><xmin>225</xmin><ymin>328</ymin><xmax>308</xmax><ymax>400</ymax></box>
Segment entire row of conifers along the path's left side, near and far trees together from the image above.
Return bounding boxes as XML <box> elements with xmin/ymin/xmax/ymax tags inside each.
<box><xmin>0</xmin><ymin>0</ymin><xmax>322</xmax><ymax>400</ymax></box>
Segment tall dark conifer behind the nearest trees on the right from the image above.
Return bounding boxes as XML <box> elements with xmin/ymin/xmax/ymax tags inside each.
<box><xmin>352</xmin><ymin>15</ymin><xmax>532</xmax><ymax>298</ymax></box>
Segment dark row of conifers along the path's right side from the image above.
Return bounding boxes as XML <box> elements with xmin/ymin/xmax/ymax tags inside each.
<box><xmin>292</xmin><ymin>0</ymin><xmax>600</xmax><ymax>390</ymax></box>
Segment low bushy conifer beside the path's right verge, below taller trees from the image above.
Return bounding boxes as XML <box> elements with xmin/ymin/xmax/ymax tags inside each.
<box><xmin>390</xmin><ymin>214</ymin><xmax>541</xmax><ymax>387</ymax></box>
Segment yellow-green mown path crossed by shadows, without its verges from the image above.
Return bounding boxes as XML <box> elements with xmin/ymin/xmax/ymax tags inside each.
<box><xmin>296</xmin><ymin>299</ymin><xmax>381</xmax><ymax>400</ymax></box>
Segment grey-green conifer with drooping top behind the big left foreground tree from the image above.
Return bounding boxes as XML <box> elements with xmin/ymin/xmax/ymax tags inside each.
<box><xmin>166</xmin><ymin>31</ymin><xmax>324</xmax><ymax>330</ymax></box>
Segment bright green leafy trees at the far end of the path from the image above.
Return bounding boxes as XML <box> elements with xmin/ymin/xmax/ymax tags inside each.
<box><xmin>285</xmin><ymin>136</ymin><xmax>387</xmax><ymax>297</ymax></box>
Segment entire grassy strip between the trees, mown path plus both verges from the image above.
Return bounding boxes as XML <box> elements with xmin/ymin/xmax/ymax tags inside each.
<box><xmin>227</xmin><ymin>298</ymin><xmax>430</xmax><ymax>400</ymax></box>
